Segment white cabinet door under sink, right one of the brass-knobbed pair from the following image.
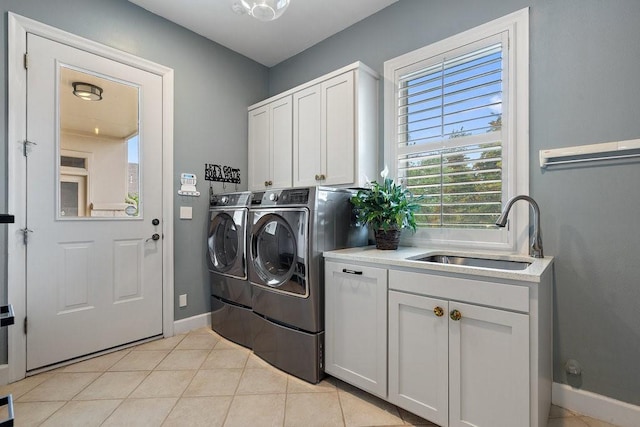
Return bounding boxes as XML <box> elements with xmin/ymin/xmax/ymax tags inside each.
<box><xmin>449</xmin><ymin>302</ymin><xmax>530</xmax><ymax>427</ymax></box>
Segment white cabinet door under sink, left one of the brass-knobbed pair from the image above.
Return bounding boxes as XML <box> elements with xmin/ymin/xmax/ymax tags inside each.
<box><xmin>389</xmin><ymin>291</ymin><xmax>449</xmax><ymax>427</ymax></box>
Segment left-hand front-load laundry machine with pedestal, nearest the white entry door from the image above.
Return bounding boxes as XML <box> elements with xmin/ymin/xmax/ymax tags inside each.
<box><xmin>207</xmin><ymin>191</ymin><xmax>252</xmax><ymax>348</ymax></box>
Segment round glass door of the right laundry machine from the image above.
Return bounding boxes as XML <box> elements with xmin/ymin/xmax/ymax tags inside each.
<box><xmin>251</xmin><ymin>211</ymin><xmax>307</xmax><ymax>296</ymax></box>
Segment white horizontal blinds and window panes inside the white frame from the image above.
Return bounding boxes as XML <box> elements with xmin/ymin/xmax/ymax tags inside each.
<box><xmin>395</xmin><ymin>41</ymin><xmax>505</xmax><ymax>228</ymax></box>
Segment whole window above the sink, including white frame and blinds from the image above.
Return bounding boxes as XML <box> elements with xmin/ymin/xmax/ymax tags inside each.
<box><xmin>384</xmin><ymin>8</ymin><xmax>529</xmax><ymax>253</ymax></box>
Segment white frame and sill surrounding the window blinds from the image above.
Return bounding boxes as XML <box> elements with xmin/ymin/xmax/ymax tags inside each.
<box><xmin>384</xmin><ymin>8</ymin><xmax>529</xmax><ymax>253</ymax></box>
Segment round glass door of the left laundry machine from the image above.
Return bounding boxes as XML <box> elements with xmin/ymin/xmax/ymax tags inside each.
<box><xmin>207</xmin><ymin>212</ymin><xmax>247</xmax><ymax>279</ymax></box>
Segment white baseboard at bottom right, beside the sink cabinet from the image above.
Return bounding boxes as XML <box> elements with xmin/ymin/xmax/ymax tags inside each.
<box><xmin>551</xmin><ymin>383</ymin><xmax>640</xmax><ymax>427</ymax></box>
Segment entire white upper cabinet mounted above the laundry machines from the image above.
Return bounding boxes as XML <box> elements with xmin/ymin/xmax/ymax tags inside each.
<box><xmin>249</xmin><ymin>62</ymin><xmax>379</xmax><ymax>190</ymax></box>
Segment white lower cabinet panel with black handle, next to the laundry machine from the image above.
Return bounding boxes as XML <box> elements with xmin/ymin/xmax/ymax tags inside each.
<box><xmin>325</xmin><ymin>261</ymin><xmax>387</xmax><ymax>398</ymax></box>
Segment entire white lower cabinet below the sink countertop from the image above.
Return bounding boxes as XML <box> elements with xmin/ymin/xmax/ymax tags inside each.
<box><xmin>325</xmin><ymin>259</ymin><xmax>552</xmax><ymax>427</ymax></box>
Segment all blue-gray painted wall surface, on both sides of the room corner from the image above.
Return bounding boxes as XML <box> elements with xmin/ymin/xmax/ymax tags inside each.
<box><xmin>0</xmin><ymin>0</ymin><xmax>640</xmax><ymax>412</ymax></box>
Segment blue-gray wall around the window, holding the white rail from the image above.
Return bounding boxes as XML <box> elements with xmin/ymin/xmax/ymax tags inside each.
<box><xmin>269</xmin><ymin>0</ymin><xmax>640</xmax><ymax>405</ymax></box>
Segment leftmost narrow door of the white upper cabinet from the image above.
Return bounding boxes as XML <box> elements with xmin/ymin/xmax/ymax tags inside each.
<box><xmin>247</xmin><ymin>105</ymin><xmax>271</xmax><ymax>190</ymax></box>
